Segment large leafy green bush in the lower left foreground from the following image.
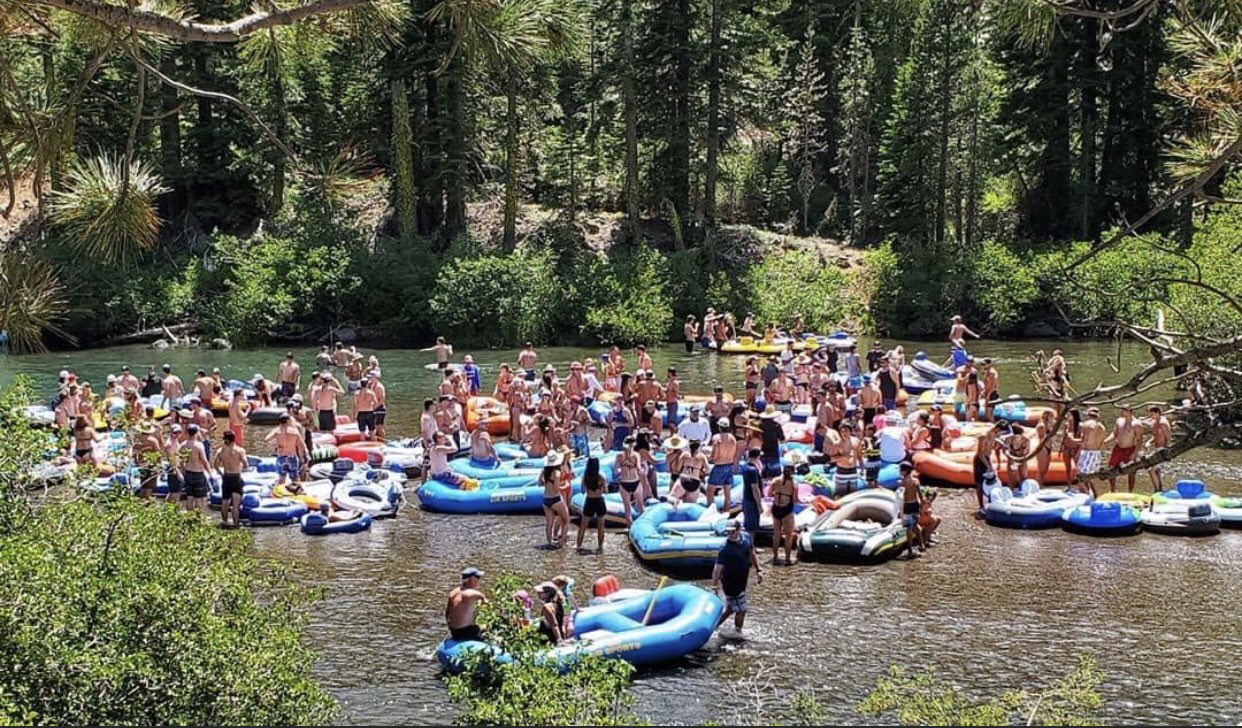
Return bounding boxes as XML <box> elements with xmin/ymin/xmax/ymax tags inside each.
<box><xmin>0</xmin><ymin>378</ymin><xmax>337</xmax><ymax>726</ymax></box>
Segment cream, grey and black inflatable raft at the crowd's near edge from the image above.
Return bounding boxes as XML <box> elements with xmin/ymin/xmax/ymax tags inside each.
<box><xmin>797</xmin><ymin>488</ymin><xmax>905</xmax><ymax>564</ymax></box>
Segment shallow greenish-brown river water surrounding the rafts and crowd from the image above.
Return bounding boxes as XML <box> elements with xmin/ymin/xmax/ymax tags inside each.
<box><xmin>0</xmin><ymin>342</ymin><xmax>1242</xmax><ymax>724</ymax></box>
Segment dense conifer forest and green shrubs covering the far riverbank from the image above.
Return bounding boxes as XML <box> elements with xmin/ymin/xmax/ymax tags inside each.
<box><xmin>0</xmin><ymin>0</ymin><xmax>1242</xmax><ymax>348</ymax></box>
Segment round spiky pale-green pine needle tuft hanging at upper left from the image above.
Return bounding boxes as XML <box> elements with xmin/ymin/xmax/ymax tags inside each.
<box><xmin>51</xmin><ymin>157</ymin><xmax>168</xmax><ymax>262</ymax></box>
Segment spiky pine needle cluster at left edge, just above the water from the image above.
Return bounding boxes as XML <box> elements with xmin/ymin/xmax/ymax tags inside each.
<box><xmin>0</xmin><ymin>251</ymin><xmax>73</xmax><ymax>354</ymax></box>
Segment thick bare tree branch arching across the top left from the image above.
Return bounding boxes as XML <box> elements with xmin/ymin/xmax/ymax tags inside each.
<box><xmin>29</xmin><ymin>0</ymin><xmax>371</xmax><ymax>43</ymax></box>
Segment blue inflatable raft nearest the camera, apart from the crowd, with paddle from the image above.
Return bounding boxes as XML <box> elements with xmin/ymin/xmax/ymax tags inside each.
<box><xmin>436</xmin><ymin>584</ymin><xmax>724</xmax><ymax>672</ymax></box>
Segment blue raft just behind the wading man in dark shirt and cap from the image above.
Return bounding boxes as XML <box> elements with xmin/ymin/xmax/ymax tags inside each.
<box><xmin>630</xmin><ymin>503</ymin><xmax>727</xmax><ymax>570</ymax></box>
